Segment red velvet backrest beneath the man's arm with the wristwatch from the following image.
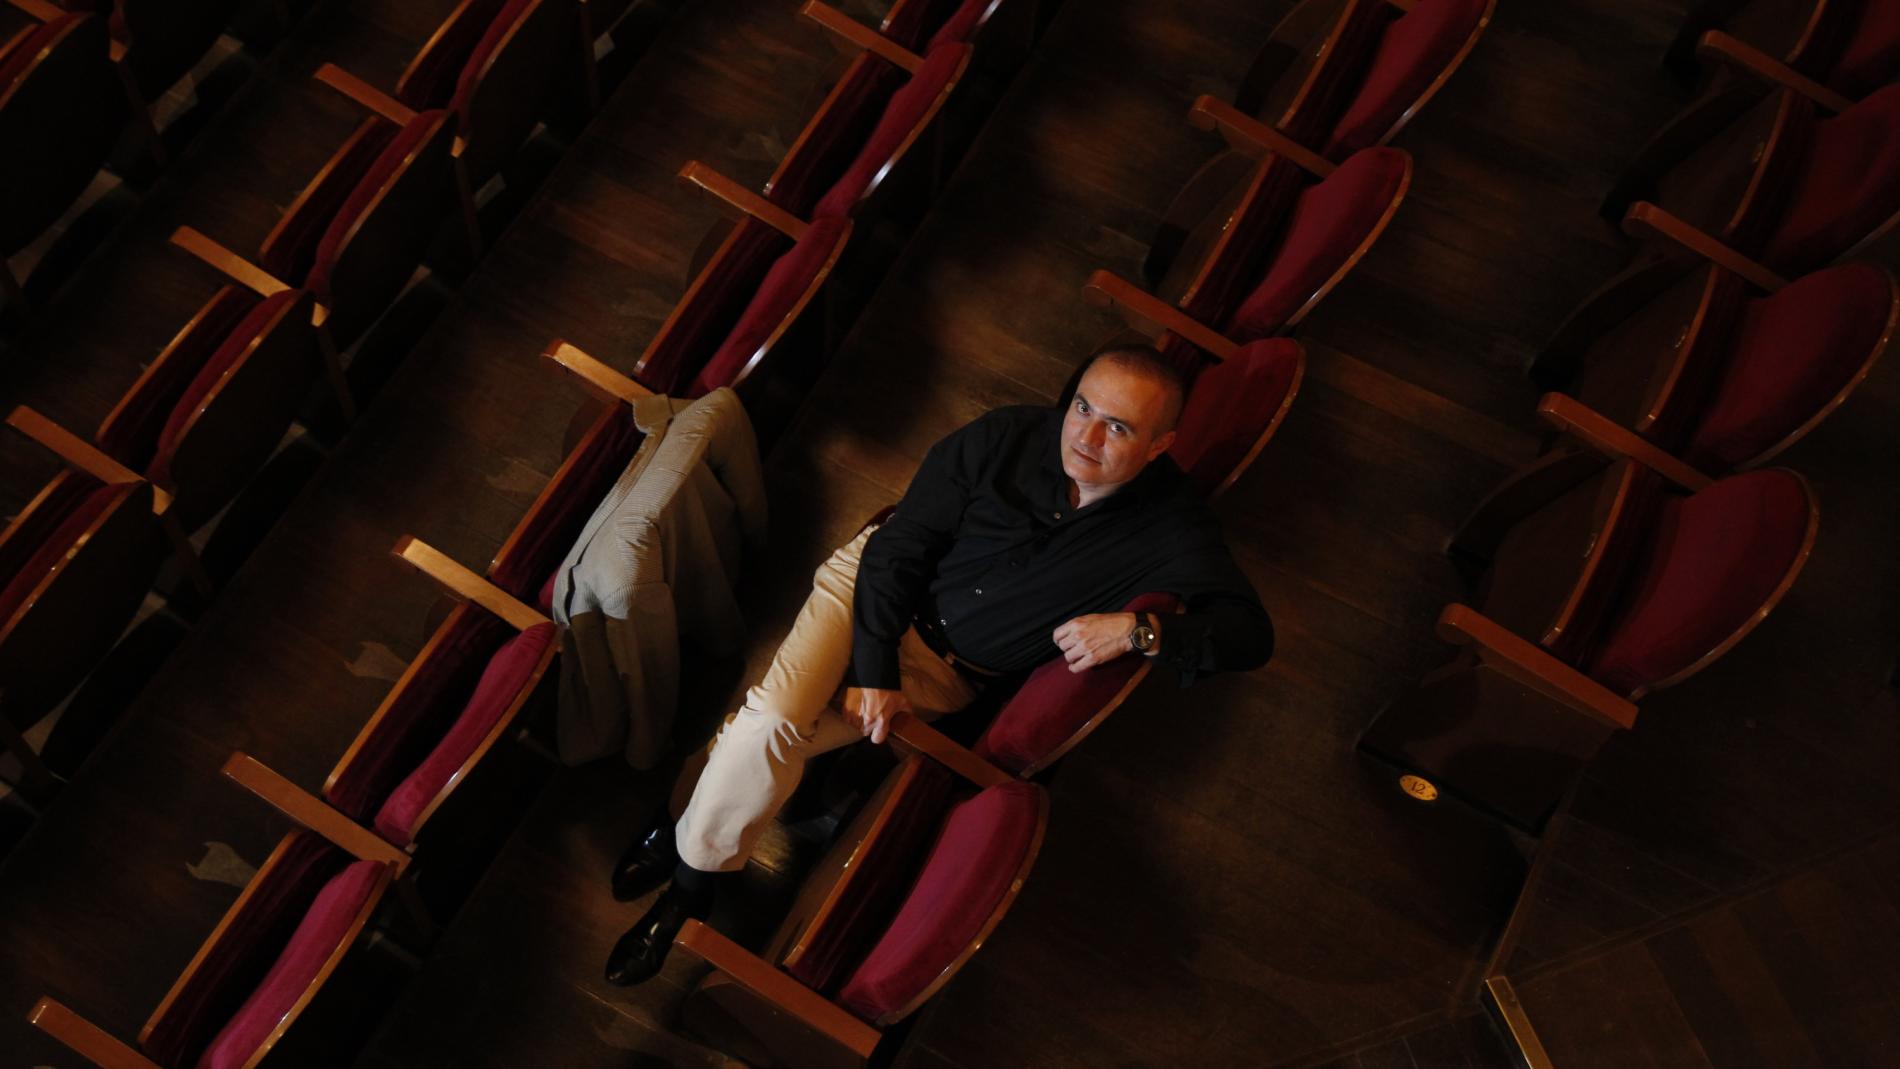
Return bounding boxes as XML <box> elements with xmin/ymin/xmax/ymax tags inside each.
<box><xmin>975</xmin><ymin>594</ymin><xmax>1180</xmax><ymax>775</ymax></box>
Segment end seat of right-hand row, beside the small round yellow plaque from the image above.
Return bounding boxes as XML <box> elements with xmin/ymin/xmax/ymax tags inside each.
<box><xmin>1360</xmin><ymin>459</ymin><xmax>1816</xmax><ymax>830</ymax></box>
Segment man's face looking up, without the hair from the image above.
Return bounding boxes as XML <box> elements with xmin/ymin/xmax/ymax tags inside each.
<box><xmin>1062</xmin><ymin>363</ymin><xmax>1174</xmax><ymax>488</ymax></box>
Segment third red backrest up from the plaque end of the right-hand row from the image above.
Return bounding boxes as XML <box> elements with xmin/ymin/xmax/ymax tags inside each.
<box><xmin>1761</xmin><ymin>85</ymin><xmax>1900</xmax><ymax>275</ymax></box>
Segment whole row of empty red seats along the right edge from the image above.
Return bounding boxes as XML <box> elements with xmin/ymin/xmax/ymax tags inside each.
<box><xmin>1362</xmin><ymin>0</ymin><xmax>1900</xmax><ymax>830</ymax></box>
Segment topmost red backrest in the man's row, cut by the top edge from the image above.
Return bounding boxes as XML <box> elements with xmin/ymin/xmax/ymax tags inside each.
<box><xmin>1322</xmin><ymin>0</ymin><xmax>1486</xmax><ymax>159</ymax></box>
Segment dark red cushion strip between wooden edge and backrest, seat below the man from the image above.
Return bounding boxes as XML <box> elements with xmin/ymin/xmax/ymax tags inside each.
<box><xmin>785</xmin><ymin>760</ymin><xmax>956</xmax><ymax>993</ymax></box>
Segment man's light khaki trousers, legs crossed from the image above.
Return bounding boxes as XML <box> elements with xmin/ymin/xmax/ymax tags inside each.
<box><xmin>675</xmin><ymin>530</ymin><xmax>977</xmax><ymax>872</ymax></box>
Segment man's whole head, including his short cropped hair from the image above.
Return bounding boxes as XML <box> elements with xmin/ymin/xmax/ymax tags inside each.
<box><xmin>1062</xmin><ymin>346</ymin><xmax>1188</xmax><ymax>497</ymax></box>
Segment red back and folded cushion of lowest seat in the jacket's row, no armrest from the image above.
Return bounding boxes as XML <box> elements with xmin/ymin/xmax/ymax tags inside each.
<box><xmin>139</xmin><ymin>830</ymin><xmax>390</xmax><ymax>1069</ymax></box>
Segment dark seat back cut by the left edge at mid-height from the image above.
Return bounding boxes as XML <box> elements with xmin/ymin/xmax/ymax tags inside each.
<box><xmin>0</xmin><ymin>471</ymin><xmax>163</xmax><ymax>727</ymax></box>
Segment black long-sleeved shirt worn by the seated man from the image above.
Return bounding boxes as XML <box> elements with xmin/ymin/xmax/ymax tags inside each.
<box><xmin>851</xmin><ymin>406</ymin><xmax>1273</xmax><ymax>689</ymax></box>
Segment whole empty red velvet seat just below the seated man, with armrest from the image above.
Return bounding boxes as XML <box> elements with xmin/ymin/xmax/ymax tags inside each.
<box><xmin>678</xmin><ymin>756</ymin><xmax>1049</xmax><ymax>1065</ymax></box>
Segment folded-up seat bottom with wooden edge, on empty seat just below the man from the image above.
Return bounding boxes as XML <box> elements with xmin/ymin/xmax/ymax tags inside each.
<box><xmin>771</xmin><ymin>756</ymin><xmax>956</xmax><ymax>991</ymax></box>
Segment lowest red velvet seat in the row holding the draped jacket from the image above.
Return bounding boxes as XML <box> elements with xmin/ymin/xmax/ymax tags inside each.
<box><xmin>29</xmin><ymin>828</ymin><xmax>397</xmax><ymax>1069</ymax></box>
